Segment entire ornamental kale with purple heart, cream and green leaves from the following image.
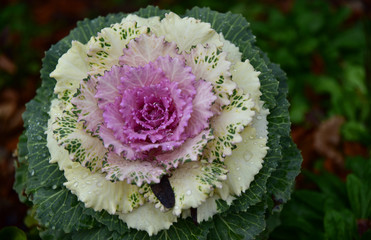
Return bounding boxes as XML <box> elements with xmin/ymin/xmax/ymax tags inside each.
<box><xmin>15</xmin><ymin>7</ymin><xmax>301</xmax><ymax>239</ymax></box>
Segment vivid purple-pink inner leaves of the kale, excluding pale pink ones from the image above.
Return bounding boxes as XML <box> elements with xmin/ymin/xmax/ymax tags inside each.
<box><xmin>97</xmin><ymin>57</ymin><xmax>200</xmax><ymax>160</ymax></box>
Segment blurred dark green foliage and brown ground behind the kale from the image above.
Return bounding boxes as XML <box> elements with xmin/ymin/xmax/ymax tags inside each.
<box><xmin>0</xmin><ymin>0</ymin><xmax>371</xmax><ymax>239</ymax></box>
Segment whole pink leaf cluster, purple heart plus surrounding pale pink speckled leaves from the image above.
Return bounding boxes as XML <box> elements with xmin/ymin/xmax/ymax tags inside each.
<box><xmin>72</xmin><ymin>34</ymin><xmax>216</xmax><ymax>184</ymax></box>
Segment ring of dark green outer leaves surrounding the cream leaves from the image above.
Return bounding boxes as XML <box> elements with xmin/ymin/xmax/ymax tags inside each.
<box><xmin>17</xmin><ymin>4</ymin><xmax>300</xmax><ymax>239</ymax></box>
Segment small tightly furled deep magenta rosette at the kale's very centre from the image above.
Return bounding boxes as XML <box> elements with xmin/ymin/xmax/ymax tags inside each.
<box><xmin>119</xmin><ymin>78</ymin><xmax>178</xmax><ymax>143</ymax></box>
